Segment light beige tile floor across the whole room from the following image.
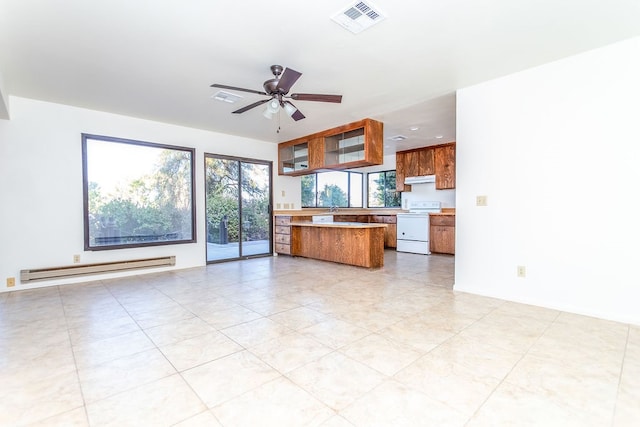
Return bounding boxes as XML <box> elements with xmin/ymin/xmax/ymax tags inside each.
<box><xmin>0</xmin><ymin>251</ymin><xmax>640</xmax><ymax>427</ymax></box>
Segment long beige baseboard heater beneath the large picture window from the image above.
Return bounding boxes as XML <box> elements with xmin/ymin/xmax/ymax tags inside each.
<box><xmin>20</xmin><ymin>256</ymin><xmax>176</xmax><ymax>283</ymax></box>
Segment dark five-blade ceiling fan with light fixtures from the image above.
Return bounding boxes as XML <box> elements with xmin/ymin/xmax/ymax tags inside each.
<box><xmin>211</xmin><ymin>65</ymin><xmax>342</xmax><ymax>121</ymax></box>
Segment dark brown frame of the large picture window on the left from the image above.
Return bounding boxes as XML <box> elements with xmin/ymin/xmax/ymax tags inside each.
<box><xmin>81</xmin><ymin>133</ymin><xmax>197</xmax><ymax>251</ymax></box>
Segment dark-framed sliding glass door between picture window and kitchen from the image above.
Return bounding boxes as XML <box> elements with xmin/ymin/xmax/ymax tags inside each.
<box><xmin>205</xmin><ymin>154</ymin><xmax>272</xmax><ymax>262</ymax></box>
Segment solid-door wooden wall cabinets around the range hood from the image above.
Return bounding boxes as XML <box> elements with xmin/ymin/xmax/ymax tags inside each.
<box><xmin>396</xmin><ymin>142</ymin><xmax>456</xmax><ymax>191</ymax></box>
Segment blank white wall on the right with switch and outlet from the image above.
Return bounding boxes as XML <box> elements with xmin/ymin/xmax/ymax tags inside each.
<box><xmin>455</xmin><ymin>38</ymin><xmax>640</xmax><ymax>324</ymax></box>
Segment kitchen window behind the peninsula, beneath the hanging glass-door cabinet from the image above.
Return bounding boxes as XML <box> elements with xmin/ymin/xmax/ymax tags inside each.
<box><xmin>301</xmin><ymin>171</ymin><xmax>362</xmax><ymax>208</ymax></box>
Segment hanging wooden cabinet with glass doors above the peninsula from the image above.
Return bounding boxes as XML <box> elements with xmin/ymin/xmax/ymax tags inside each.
<box><xmin>278</xmin><ymin>119</ymin><xmax>383</xmax><ymax>175</ymax></box>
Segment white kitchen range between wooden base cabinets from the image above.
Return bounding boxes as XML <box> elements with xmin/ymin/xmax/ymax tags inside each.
<box><xmin>396</xmin><ymin>200</ymin><xmax>442</xmax><ymax>255</ymax></box>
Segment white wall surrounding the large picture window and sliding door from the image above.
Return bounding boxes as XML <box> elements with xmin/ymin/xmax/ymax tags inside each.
<box><xmin>0</xmin><ymin>97</ymin><xmax>282</xmax><ymax>292</ymax></box>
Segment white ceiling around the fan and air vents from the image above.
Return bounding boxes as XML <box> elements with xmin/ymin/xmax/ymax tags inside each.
<box><xmin>0</xmin><ymin>0</ymin><xmax>640</xmax><ymax>153</ymax></box>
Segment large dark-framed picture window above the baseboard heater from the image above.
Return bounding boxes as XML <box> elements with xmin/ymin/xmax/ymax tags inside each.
<box><xmin>82</xmin><ymin>134</ymin><xmax>196</xmax><ymax>250</ymax></box>
